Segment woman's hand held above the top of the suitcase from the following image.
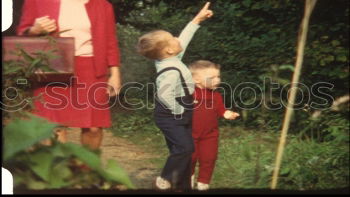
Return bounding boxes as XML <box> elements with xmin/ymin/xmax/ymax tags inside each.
<box><xmin>28</xmin><ymin>16</ymin><xmax>57</xmax><ymax>36</ymax></box>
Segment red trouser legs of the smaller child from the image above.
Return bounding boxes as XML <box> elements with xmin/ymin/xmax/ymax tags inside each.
<box><xmin>191</xmin><ymin>129</ymin><xmax>219</xmax><ymax>184</ymax></box>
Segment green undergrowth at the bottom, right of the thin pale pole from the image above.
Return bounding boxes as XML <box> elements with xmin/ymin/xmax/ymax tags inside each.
<box><xmin>279</xmin><ymin>133</ymin><xmax>349</xmax><ymax>190</ymax></box>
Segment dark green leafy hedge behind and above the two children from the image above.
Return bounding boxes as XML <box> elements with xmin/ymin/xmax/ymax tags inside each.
<box><xmin>119</xmin><ymin>0</ymin><xmax>349</xmax><ymax>121</ymax></box>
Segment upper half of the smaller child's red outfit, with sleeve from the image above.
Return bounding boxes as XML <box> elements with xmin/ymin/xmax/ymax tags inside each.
<box><xmin>192</xmin><ymin>87</ymin><xmax>226</xmax><ymax>139</ymax></box>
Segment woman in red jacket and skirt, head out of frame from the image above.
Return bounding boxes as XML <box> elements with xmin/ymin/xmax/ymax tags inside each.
<box><xmin>17</xmin><ymin>0</ymin><xmax>121</xmax><ymax>149</ymax></box>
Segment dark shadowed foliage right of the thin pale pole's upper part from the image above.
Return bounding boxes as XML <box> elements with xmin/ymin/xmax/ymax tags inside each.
<box><xmin>306</xmin><ymin>0</ymin><xmax>349</xmax><ymax>82</ymax></box>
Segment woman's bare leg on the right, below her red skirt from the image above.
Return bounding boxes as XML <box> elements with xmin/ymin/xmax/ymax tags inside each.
<box><xmin>80</xmin><ymin>127</ymin><xmax>103</xmax><ymax>150</ymax></box>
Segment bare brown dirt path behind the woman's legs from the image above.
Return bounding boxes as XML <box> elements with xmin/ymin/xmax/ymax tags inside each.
<box><xmin>68</xmin><ymin>128</ymin><xmax>160</xmax><ymax>189</ymax></box>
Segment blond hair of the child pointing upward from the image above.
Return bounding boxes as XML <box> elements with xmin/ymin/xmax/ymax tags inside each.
<box><xmin>136</xmin><ymin>30</ymin><xmax>169</xmax><ymax>60</ymax></box>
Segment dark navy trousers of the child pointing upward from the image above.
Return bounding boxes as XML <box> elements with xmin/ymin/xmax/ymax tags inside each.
<box><xmin>155</xmin><ymin>104</ymin><xmax>194</xmax><ymax>189</ymax></box>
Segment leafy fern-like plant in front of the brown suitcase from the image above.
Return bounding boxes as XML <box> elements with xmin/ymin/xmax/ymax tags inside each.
<box><xmin>2</xmin><ymin>36</ymin><xmax>59</xmax><ymax>118</ymax></box>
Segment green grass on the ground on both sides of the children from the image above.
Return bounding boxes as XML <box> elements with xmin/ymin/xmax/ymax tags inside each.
<box><xmin>108</xmin><ymin>106</ymin><xmax>349</xmax><ymax>190</ymax></box>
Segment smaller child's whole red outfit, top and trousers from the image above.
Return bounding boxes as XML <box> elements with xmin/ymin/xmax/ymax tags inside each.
<box><xmin>192</xmin><ymin>87</ymin><xmax>226</xmax><ymax>184</ymax></box>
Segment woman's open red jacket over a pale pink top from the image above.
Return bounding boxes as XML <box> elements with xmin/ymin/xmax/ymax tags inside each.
<box><xmin>17</xmin><ymin>0</ymin><xmax>120</xmax><ymax>77</ymax></box>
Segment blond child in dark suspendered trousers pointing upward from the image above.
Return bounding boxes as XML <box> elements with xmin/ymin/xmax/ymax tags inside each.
<box><xmin>137</xmin><ymin>2</ymin><xmax>213</xmax><ymax>190</ymax></box>
